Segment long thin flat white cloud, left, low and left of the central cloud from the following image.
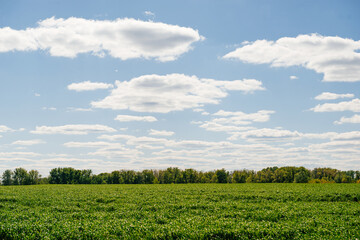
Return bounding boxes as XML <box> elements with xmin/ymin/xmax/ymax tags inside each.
<box><xmin>30</xmin><ymin>124</ymin><xmax>116</xmax><ymax>135</ymax></box>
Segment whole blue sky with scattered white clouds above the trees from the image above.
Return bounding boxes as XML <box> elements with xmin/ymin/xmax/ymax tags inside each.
<box><xmin>0</xmin><ymin>0</ymin><xmax>360</xmax><ymax>176</ymax></box>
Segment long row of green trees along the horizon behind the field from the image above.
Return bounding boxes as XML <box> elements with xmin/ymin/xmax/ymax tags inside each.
<box><xmin>1</xmin><ymin>167</ymin><xmax>360</xmax><ymax>185</ymax></box>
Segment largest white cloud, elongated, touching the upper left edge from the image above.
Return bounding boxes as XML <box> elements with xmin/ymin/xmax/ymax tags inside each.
<box><xmin>0</xmin><ymin>17</ymin><xmax>204</xmax><ymax>61</ymax></box>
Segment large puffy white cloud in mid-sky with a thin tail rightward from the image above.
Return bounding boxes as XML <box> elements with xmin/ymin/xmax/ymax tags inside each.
<box><xmin>91</xmin><ymin>74</ymin><xmax>264</xmax><ymax>113</ymax></box>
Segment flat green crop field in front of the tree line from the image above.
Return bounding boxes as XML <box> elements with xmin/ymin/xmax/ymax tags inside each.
<box><xmin>0</xmin><ymin>183</ymin><xmax>360</xmax><ymax>239</ymax></box>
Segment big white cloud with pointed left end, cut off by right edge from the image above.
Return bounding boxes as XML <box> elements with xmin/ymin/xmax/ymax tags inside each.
<box><xmin>223</xmin><ymin>34</ymin><xmax>360</xmax><ymax>82</ymax></box>
